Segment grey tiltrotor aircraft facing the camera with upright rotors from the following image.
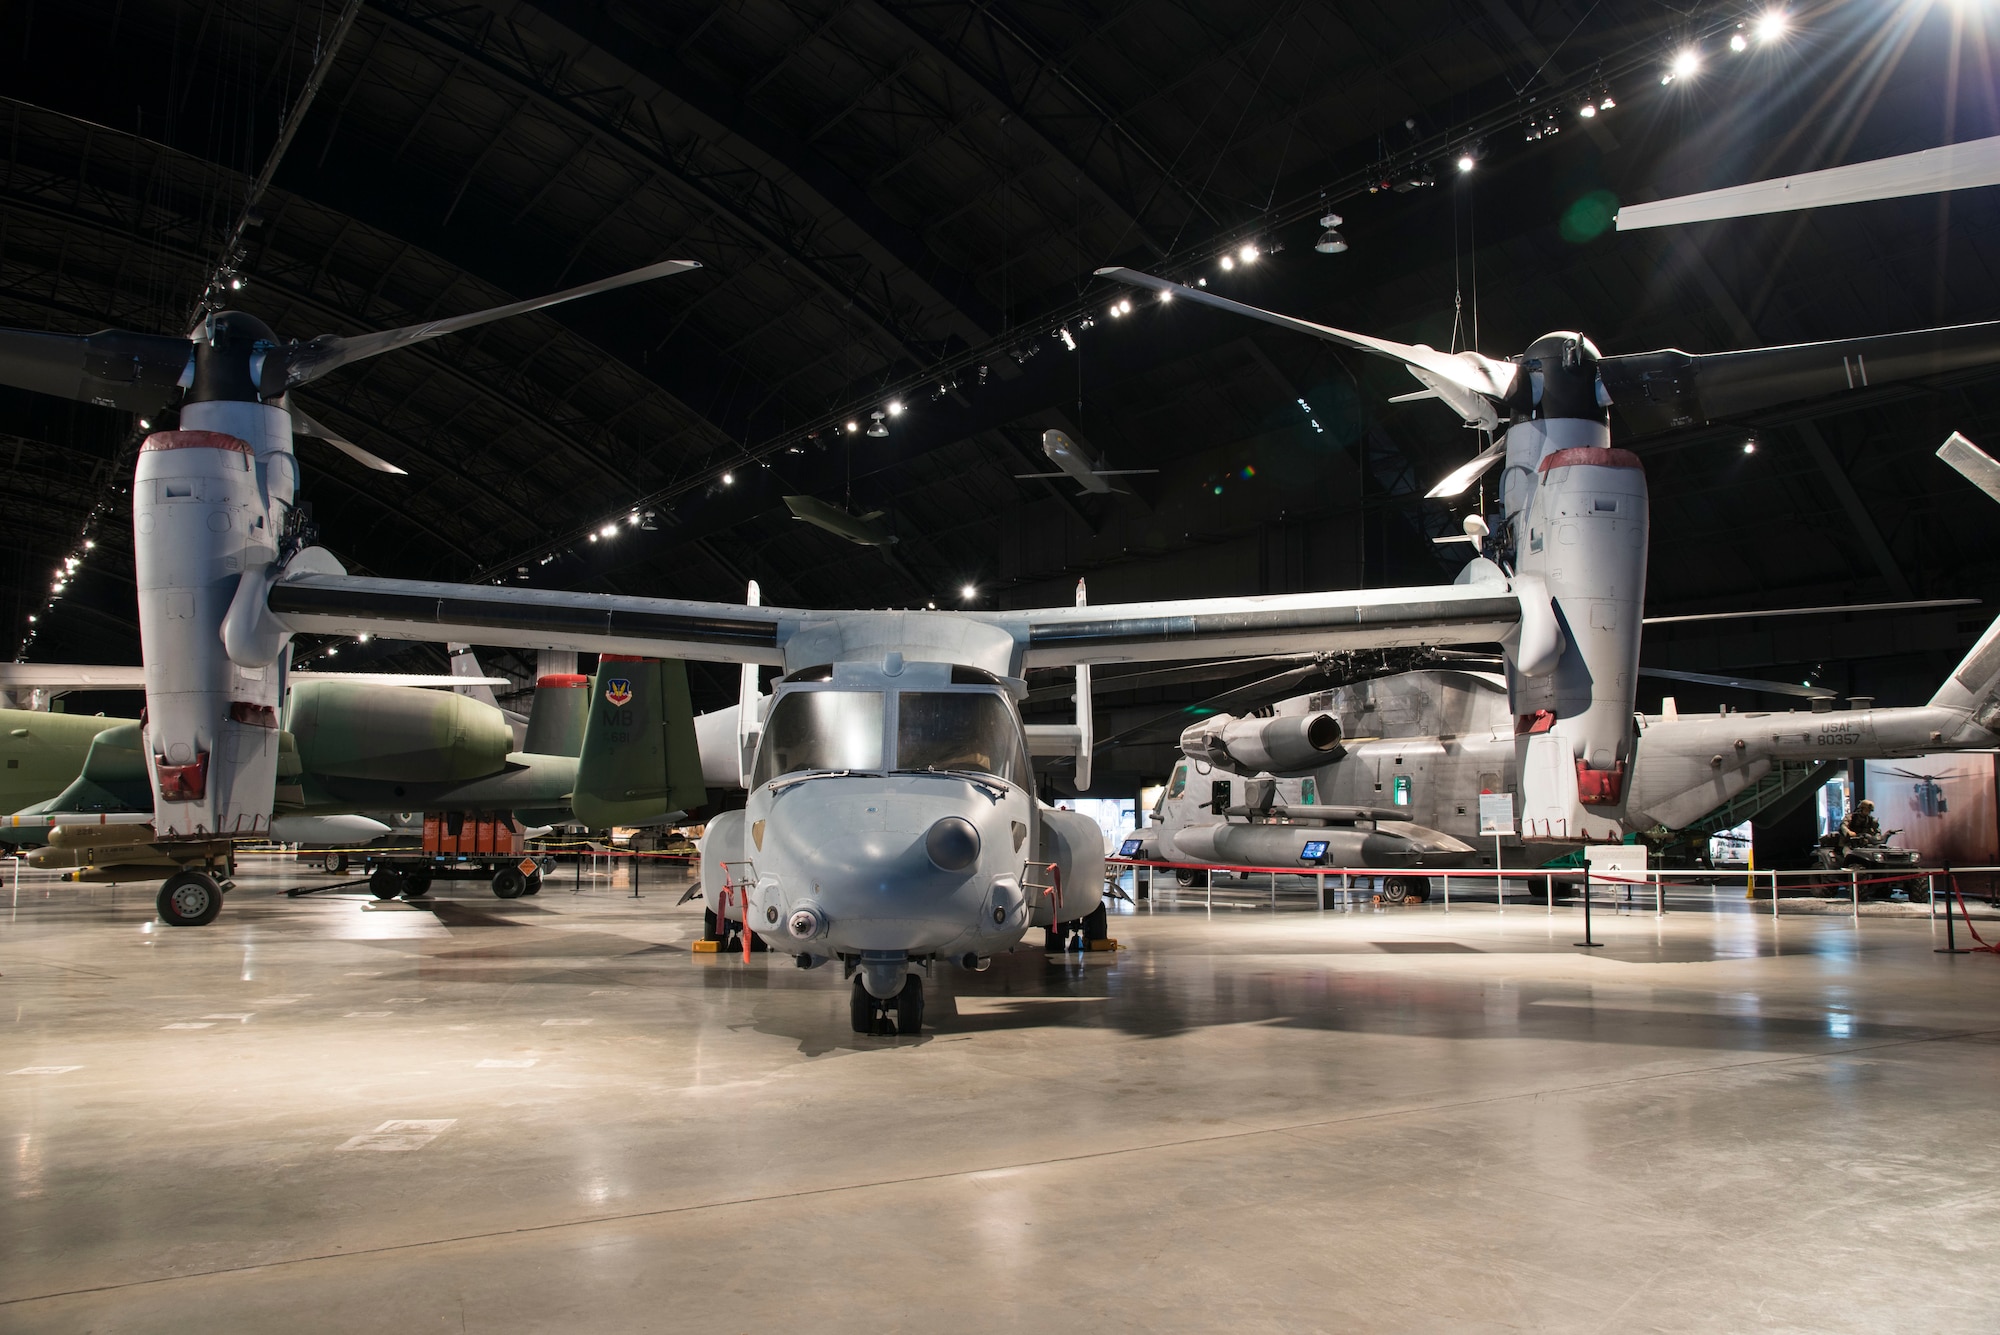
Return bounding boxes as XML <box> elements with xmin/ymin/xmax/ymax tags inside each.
<box><xmin>0</xmin><ymin>252</ymin><xmax>2000</xmax><ymax>1029</ymax></box>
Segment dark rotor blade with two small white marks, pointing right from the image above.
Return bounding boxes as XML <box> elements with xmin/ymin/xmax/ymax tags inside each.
<box><xmin>1598</xmin><ymin>320</ymin><xmax>2000</xmax><ymax>436</ymax></box>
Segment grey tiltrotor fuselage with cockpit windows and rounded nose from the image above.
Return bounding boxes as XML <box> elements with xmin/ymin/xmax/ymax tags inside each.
<box><xmin>702</xmin><ymin>658</ymin><xmax>1102</xmax><ymax>995</ymax></box>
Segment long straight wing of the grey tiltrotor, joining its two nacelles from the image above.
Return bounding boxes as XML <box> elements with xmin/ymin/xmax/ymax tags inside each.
<box><xmin>268</xmin><ymin>574</ymin><xmax>1528</xmax><ymax>675</ymax></box>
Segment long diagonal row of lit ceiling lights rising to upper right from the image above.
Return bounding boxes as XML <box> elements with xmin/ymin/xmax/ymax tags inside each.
<box><xmin>460</xmin><ymin>10</ymin><xmax>1788</xmax><ymax>580</ymax></box>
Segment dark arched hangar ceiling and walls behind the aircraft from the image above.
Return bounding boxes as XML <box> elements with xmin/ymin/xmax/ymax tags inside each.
<box><xmin>0</xmin><ymin>0</ymin><xmax>2000</xmax><ymax>791</ymax></box>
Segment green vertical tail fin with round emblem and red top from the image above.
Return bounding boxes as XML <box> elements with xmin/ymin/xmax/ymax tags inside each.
<box><xmin>572</xmin><ymin>656</ymin><xmax>708</xmax><ymax>829</ymax></box>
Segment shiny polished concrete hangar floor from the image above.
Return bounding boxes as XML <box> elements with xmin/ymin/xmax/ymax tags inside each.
<box><xmin>0</xmin><ymin>863</ymin><xmax>2000</xmax><ymax>1335</ymax></box>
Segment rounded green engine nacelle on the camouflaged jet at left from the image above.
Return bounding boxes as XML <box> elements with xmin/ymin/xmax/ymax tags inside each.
<box><xmin>286</xmin><ymin>681</ymin><xmax>514</xmax><ymax>783</ymax></box>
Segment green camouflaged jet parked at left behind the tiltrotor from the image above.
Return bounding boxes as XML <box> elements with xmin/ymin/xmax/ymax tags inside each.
<box><xmin>0</xmin><ymin>662</ymin><xmax>706</xmax><ymax>907</ymax></box>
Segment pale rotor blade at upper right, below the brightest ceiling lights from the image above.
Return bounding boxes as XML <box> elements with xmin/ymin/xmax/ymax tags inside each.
<box><xmin>1614</xmin><ymin>138</ymin><xmax>2000</xmax><ymax>232</ymax></box>
